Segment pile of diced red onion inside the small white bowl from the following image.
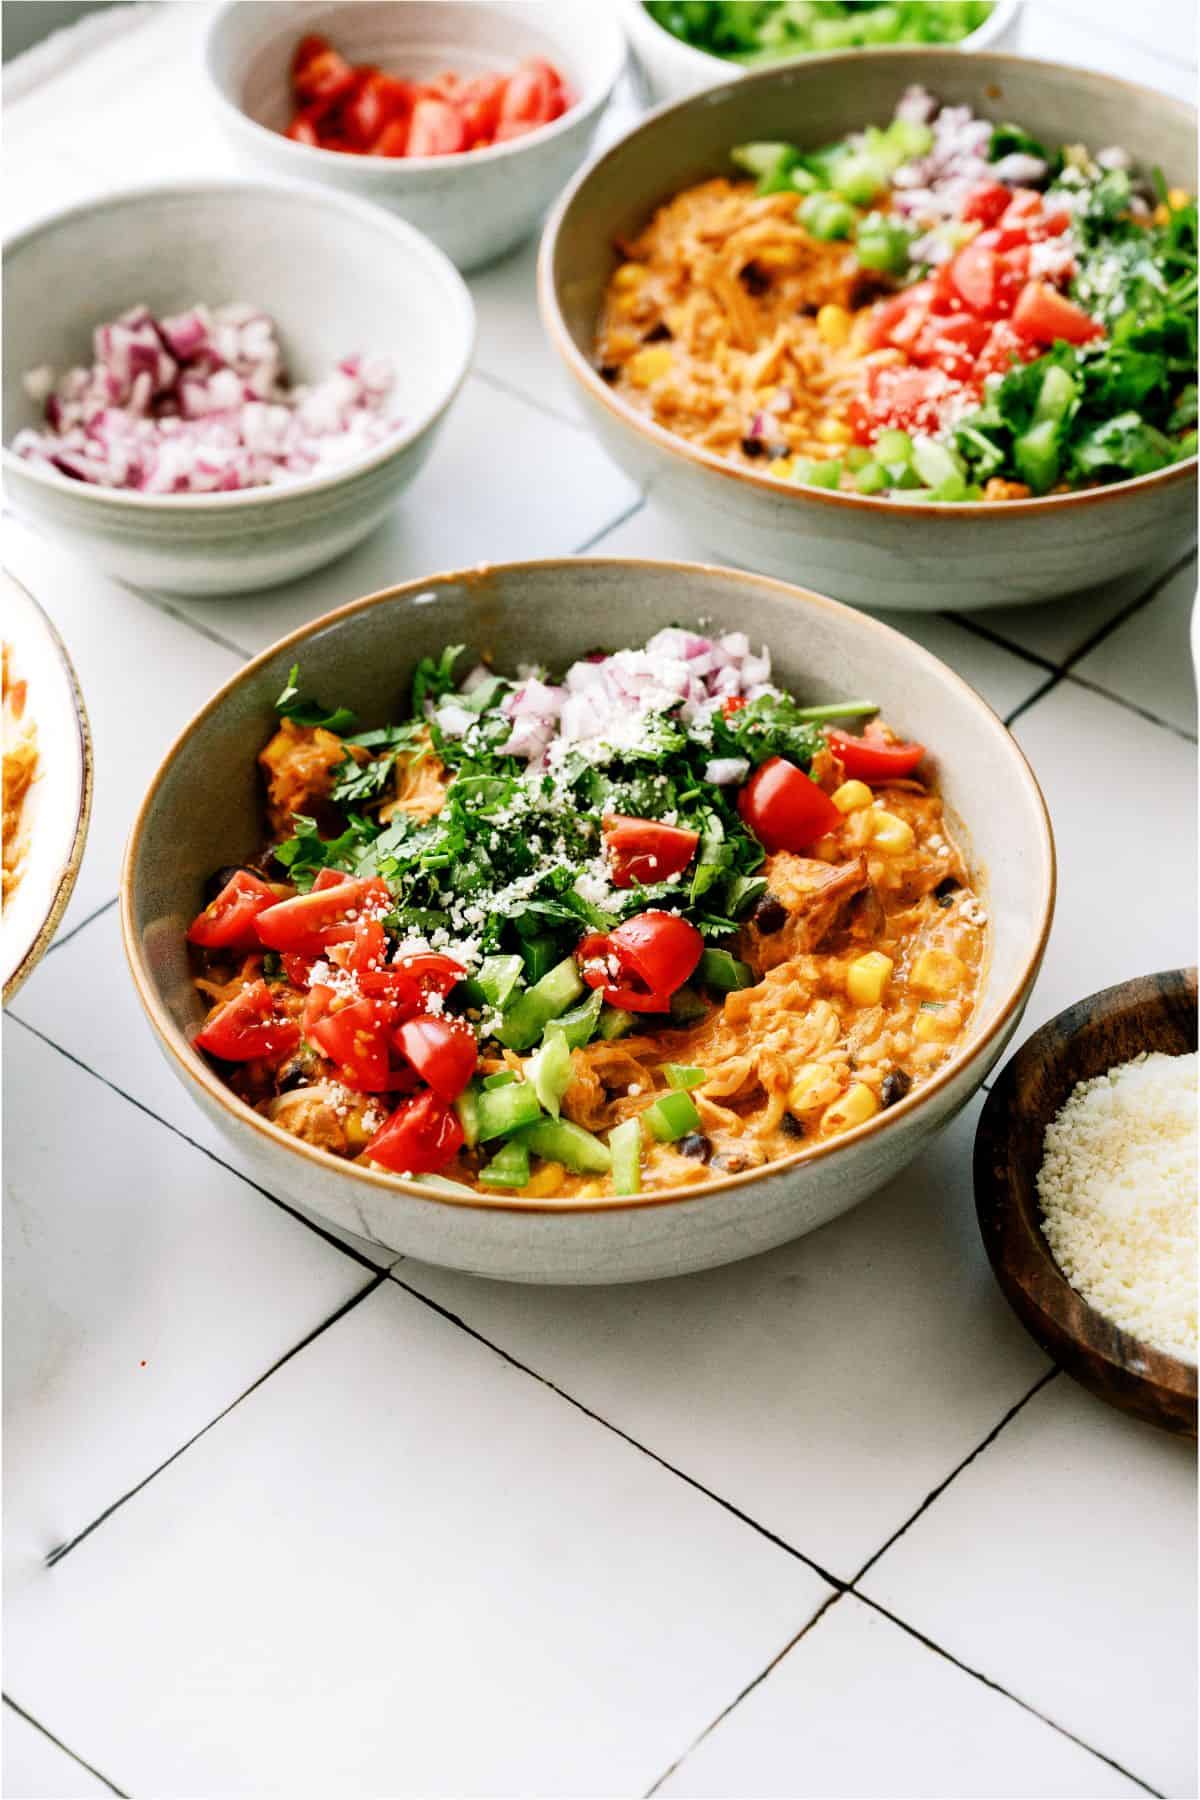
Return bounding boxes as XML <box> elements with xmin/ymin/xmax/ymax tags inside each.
<box><xmin>13</xmin><ymin>301</ymin><xmax>398</xmax><ymax>493</ymax></box>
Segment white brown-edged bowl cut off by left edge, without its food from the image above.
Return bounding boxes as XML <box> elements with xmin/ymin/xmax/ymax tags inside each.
<box><xmin>0</xmin><ymin>569</ymin><xmax>92</xmax><ymax>1006</ymax></box>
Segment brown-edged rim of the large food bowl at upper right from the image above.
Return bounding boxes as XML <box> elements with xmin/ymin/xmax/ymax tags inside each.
<box><xmin>538</xmin><ymin>45</ymin><xmax>1196</xmax><ymax>524</ymax></box>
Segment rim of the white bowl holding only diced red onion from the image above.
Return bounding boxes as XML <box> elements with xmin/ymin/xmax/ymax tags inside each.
<box><xmin>0</xmin><ymin>175</ymin><xmax>479</xmax><ymax>517</ymax></box>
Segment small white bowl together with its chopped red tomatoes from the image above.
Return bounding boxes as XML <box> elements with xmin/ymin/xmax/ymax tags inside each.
<box><xmin>205</xmin><ymin>0</ymin><xmax>624</xmax><ymax>268</ymax></box>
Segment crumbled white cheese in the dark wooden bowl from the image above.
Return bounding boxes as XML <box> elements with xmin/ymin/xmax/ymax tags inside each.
<box><xmin>1038</xmin><ymin>1051</ymin><xmax>1196</xmax><ymax>1363</ymax></box>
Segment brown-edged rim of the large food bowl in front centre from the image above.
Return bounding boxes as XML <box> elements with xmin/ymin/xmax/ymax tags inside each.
<box><xmin>121</xmin><ymin>556</ymin><xmax>1058</xmax><ymax>1213</ymax></box>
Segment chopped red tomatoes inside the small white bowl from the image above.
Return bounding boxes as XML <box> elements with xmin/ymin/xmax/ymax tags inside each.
<box><xmin>286</xmin><ymin>32</ymin><xmax>572</xmax><ymax>157</ymax></box>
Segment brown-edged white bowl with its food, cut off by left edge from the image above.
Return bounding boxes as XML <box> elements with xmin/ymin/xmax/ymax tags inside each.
<box><xmin>0</xmin><ymin>569</ymin><xmax>92</xmax><ymax>1004</ymax></box>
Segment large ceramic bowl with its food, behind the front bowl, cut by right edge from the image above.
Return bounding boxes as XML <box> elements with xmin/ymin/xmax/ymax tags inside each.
<box><xmin>540</xmin><ymin>50</ymin><xmax>1196</xmax><ymax>608</ymax></box>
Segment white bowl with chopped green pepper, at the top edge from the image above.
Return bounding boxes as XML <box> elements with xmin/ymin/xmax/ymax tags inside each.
<box><xmin>621</xmin><ymin>0</ymin><xmax>1016</xmax><ymax>101</ymax></box>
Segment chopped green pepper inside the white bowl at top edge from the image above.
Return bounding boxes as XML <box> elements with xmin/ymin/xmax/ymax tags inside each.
<box><xmin>646</xmin><ymin>0</ymin><xmax>993</xmax><ymax>68</ymax></box>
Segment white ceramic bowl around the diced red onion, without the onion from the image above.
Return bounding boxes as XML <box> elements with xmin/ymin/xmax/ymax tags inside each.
<box><xmin>4</xmin><ymin>180</ymin><xmax>475</xmax><ymax>594</ymax></box>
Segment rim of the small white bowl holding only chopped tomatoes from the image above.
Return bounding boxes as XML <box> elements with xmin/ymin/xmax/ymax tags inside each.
<box><xmin>200</xmin><ymin>0</ymin><xmax>626</xmax><ymax>177</ymax></box>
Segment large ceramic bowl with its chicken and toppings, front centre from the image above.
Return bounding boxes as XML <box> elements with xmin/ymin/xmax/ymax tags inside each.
<box><xmin>122</xmin><ymin>558</ymin><xmax>1054</xmax><ymax>1282</ymax></box>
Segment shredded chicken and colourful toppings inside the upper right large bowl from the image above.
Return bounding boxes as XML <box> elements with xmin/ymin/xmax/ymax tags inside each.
<box><xmin>597</xmin><ymin>88</ymin><xmax>1196</xmax><ymax>502</ymax></box>
